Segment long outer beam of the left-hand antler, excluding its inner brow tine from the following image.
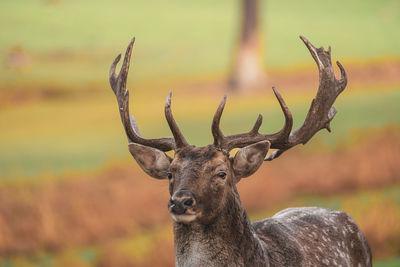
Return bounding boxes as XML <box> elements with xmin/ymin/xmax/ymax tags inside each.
<box><xmin>109</xmin><ymin>37</ymin><xmax>175</xmax><ymax>151</ymax></box>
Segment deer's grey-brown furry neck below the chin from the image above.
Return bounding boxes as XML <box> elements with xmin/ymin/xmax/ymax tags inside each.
<box><xmin>174</xmin><ymin>189</ymin><xmax>269</xmax><ymax>267</ymax></box>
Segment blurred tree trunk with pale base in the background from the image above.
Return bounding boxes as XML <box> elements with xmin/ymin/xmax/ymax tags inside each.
<box><xmin>228</xmin><ymin>0</ymin><xmax>265</xmax><ymax>91</ymax></box>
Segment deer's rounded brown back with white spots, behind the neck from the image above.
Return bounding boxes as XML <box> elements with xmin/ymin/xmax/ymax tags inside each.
<box><xmin>252</xmin><ymin>207</ymin><xmax>372</xmax><ymax>267</ymax></box>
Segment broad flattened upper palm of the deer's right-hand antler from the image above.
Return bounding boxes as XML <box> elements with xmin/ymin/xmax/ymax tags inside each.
<box><xmin>266</xmin><ymin>36</ymin><xmax>347</xmax><ymax>160</ymax></box>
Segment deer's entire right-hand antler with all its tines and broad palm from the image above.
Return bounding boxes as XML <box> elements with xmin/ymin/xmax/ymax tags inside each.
<box><xmin>211</xmin><ymin>36</ymin><xmax>347</xmax><ymax>160</ymax></box>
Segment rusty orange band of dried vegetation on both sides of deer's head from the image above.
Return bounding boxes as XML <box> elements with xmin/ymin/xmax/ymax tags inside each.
<box><xmin>0</xmin><ymin>128</ymin><xmax>400</xmax><ymax>260</ymax></box>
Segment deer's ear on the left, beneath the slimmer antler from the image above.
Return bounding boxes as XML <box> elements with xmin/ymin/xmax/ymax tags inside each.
<box><xmin>129</xmin><ymin>143</ymin><xmax>171</xmax><ymax>179</ymax></box>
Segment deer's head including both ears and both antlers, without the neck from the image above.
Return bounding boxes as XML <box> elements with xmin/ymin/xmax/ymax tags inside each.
<box><xmin>110</xmin><ymin>36</ymin><xmax>347</xmax><ymax>224</ymax></box>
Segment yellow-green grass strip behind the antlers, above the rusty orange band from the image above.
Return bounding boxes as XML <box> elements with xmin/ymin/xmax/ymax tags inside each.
<box><xmin>0</xmin><ymin>87</ymin><xmax>400</xmax><ymax>178</ymax></box>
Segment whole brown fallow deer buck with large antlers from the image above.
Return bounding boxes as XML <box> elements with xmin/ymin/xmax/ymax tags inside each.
<box><xmin>110</xmin><ymin>36</ymin><xmax>372</xmax><ymax>266</ymax></box>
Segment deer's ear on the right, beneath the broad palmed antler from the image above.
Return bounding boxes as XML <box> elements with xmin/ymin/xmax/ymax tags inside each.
<box><xmin>233</xmin><ymin>141</ymin><xmax>271</xmax><ymax>181</ymax></box>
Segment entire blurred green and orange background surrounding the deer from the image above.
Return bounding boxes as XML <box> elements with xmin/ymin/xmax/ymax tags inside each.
<box><xmin>0</xmin><ymin>0</ymin><xmax>400</xmax><ymax>267</ymax></box>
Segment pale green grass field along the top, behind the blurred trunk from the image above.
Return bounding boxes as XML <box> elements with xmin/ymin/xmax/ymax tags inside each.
<box><xmin>0</xmin><ymin>0</ymin><xmax>400</xmax><ymax>90</ymax></box>
